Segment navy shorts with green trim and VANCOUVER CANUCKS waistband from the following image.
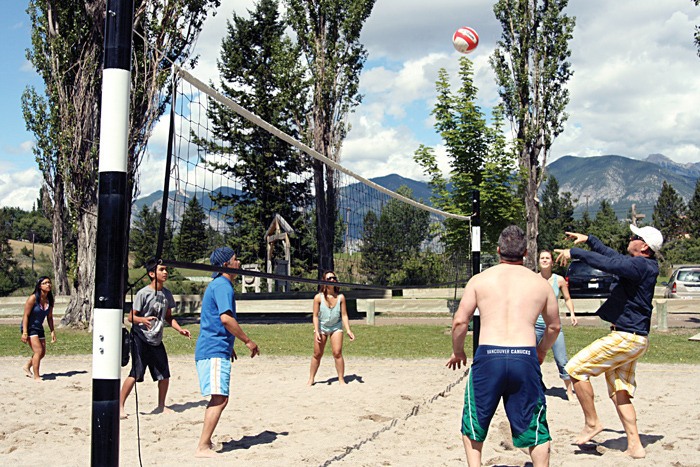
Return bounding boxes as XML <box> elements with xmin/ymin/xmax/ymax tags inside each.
<box><xmin>462</xmin><ymin>345</ymin><xmax>552</xmax><ymax>448</ymax></box>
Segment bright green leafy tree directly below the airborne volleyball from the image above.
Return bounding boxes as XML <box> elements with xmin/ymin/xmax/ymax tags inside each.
<box><xmin>414</xmin><ymin>57</ymin><xmax>523</xmax><ymax>252</ymax></box>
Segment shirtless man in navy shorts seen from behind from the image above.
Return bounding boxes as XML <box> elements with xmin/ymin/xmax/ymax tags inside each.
<box><xmin>447</xmin><ymin>225</ymin><xmax>561</xmax><ymax>467</ymax></box>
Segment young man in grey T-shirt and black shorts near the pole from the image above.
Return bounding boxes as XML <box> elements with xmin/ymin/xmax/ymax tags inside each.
<box><xmin>119</xmin><ymin>259</ymin><xmax>191</xmax><ymax>419</ymax></box>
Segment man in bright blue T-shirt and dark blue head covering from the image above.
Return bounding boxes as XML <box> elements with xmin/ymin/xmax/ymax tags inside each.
<box><xmin>194</xmin><ymin>247</ymin><xmax>260</xmax><ymax>457</ymax></box>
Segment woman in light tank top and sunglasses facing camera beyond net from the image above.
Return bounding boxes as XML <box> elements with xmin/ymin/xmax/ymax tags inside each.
<box><xmin>307</xmin><ymin>271</ymin><xmax>355</xmax><ymax>386</ymax></box>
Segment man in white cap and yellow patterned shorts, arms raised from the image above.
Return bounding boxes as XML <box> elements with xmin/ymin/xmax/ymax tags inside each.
<box><xmin>554</xmin><ymin>225</ymin><xmax>663</xmax><ymax>458</ymax></box>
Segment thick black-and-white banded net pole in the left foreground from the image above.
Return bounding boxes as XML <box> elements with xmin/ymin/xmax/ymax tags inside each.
<box><xmin>90</xmin><ymin>0</ymin><xmax>134</xmax><ymax>466</ymax></box>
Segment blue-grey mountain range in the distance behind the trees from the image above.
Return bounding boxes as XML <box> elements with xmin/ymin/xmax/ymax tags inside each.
<box><xmin>134</xmin><ymin>154</ymin><xmax>700</xmax><ymax>225</ymax></box>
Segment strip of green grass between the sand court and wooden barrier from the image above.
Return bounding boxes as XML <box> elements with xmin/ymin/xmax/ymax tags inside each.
<box><xmin>0</xmin><ymin>321</ymin><xmax>700</xmax><ymax>364</ymax></box>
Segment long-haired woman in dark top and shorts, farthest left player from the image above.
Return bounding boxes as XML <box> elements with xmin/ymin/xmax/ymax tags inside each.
<box><xmin>20</xmin><ymin>276</ymin><xmax>56</xmax><ymax>381</ymax></box>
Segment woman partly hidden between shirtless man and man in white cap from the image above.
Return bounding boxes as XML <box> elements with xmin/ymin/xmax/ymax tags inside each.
<box><xmin>535</xmin><ymin>250</ymin><xmax>578</xmax><ymax>400</ymax></box>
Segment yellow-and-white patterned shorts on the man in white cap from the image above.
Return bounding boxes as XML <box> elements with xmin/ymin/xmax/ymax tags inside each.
<box><xmin>566</xmin><ymin>331</ymin><xmax>649</xmax><ymax>397</ymax></box>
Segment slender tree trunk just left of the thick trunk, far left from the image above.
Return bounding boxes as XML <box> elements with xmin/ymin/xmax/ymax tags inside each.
<box><xmin>42</xmin><ymin>181</ymin><xmax>70</xmax><ymax>295</ymax></box>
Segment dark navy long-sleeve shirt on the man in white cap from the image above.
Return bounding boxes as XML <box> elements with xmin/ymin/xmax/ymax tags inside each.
<box><xmin>571</xmin><ymin>235</ymin><xmax>659</xmax><ymax>335</ymax></box>
